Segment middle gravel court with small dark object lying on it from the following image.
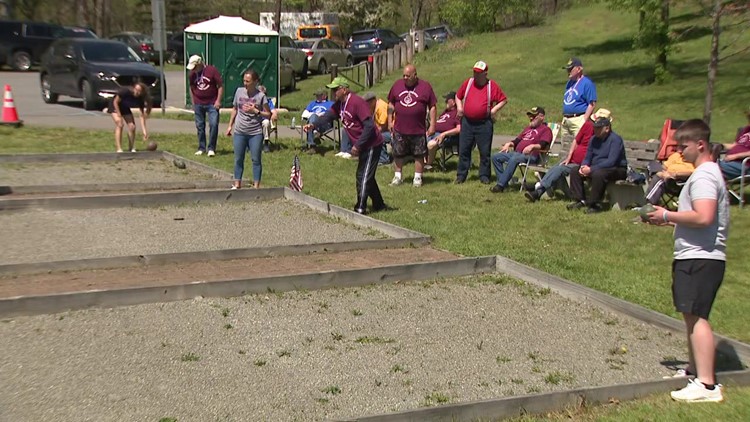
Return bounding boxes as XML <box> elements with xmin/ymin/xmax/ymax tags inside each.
<box><xmin>0</xmin><ymin>200</ymin><xmax>383</xmax><ymax>264</ymax></box>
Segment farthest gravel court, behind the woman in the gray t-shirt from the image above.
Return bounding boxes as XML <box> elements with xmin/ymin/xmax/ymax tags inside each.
<box><xmin>0</xmin><ymin>160</ymin><xmax>220</xmax><ymax>186</ymax></box>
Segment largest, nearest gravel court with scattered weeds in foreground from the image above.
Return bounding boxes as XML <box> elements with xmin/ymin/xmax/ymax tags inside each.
<box><xmin>0</xmin><ymin>275</ymin><xmax>686</xmax><ymax>422</ymax></box>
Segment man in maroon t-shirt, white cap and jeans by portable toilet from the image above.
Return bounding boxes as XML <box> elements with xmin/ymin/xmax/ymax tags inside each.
<box><xmin>186</xmin><ymin>55</ymin><xmax>224</xmax><ymax>157</ymax></box>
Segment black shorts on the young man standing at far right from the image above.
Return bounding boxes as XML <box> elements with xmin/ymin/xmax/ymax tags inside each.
<box><xmin>672</xmin><ymin>259</ymin><xmax>726</xmax><ymax>319</ymax></box>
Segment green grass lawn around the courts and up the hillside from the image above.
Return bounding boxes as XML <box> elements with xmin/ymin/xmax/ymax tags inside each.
<box><xmin>0</xmin><ymin>4</ymin><xmax>750</xmax><ymax>421</ymax></box>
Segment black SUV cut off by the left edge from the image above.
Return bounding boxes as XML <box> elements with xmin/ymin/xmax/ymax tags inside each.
<box><xmin>0</xmin><ymin>21</ymin><xmax>65</xmax><ymax>71</ymax></box>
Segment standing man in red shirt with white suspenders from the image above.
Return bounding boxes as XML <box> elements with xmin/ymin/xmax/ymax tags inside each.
<box><xmin>455</xmin><ymin>60</ymin><xmax>508</xmax><ymax>184</ymax></box>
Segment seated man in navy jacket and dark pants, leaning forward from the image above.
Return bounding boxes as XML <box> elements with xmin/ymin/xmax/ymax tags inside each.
<box><xmin>568</xmin><ymin>117</ymin><xmax>628</xmax><ymax>214</ymax></box>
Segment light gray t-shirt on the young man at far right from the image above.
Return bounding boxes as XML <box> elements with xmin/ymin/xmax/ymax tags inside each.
<box><xmin>674</xmin><ymin>162</ymin><xmax>729</xmax><ymax>261</ymax></box>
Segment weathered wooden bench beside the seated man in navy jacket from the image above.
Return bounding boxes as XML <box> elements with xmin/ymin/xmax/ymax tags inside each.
<box><xmin>607</xmin><ymin>141</ymin><xmax>661</xmax><ymax>210</ymax></box>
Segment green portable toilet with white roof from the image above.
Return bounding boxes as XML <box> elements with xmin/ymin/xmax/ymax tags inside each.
<box><xmin>185</xmin><ymin>16</ymin><xmax>279</xmax><ymax>107</ymax></box>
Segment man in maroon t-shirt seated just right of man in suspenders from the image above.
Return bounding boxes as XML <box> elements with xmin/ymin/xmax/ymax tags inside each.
<box><xmin>490</xmin><ymin>106</ymin><xmax>552</xmax><ymax>193</ymax></box>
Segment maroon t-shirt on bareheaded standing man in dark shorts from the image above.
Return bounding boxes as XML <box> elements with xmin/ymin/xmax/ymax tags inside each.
<box><xmin>388</xmin><ymin>79</ymin><xmax>437</xmax><ymax>135</ymax></box>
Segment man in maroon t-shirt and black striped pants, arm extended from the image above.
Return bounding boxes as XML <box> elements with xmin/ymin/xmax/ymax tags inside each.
<box><xmin>303</xmin><ymin>76</ymin><xmax>388</xmax><ymax>214</ymax></box>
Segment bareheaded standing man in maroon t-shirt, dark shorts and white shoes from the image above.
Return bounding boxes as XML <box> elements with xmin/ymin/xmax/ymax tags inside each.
<box><xmin>388</xmin><ymin>64</ymin><xmax>437</xmax><ymax>187</ymax></box>
